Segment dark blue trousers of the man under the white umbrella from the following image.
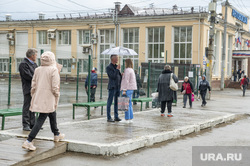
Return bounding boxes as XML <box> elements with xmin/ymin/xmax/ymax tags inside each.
<box><xmin>107</xmin><ymin>89</ymin><xmax>120</xmax><ymax>120</ymax></box>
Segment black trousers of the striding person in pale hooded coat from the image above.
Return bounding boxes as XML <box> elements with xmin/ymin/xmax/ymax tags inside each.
<box><xmin>28</xmin><ymin>111</ymin><xmax>60</xmax><ymax>142</ymax></box>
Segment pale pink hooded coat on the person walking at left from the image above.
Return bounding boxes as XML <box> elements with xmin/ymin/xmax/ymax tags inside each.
<box><xmin>30</xmin><ymin>52</ymin><xmax>60</xmax><ymax>113</ymax></box>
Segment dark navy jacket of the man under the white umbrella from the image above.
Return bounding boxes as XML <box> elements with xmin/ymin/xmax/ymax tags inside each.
<box><xmin>106</xmin><ymin>63</ymin><xmax>122</xmax><ymax>90</ymax></box>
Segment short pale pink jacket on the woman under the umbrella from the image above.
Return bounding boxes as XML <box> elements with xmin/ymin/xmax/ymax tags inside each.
<box><xmin>121</xmin><ymin>68</ymin><xmax>137</xmax><ymax>90</ymax></box>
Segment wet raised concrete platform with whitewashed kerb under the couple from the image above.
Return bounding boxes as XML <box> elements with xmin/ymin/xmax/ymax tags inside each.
<box><xmin>0</xmin><ymin>108</ymin><xmax>236</xmax><ymax>155</ymax></box>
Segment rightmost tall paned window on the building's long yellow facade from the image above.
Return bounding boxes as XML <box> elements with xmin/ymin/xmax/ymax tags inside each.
<box><xmin>173</xmin><ymin>27</ymin><xmax>192</xmax><ymax>64</ymax></box>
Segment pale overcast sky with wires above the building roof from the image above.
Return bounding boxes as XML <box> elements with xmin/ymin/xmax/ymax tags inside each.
<box><xmin>0</xmin><ymin>0</ymin><xmax>250</xmax><ymax>20</ymax></box>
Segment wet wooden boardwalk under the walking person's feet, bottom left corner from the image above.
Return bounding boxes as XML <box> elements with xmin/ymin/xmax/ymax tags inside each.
<box><xmin>0</xmin><ymin>138</ymin><xmax>67</xmax><ymax>166</ymax></box>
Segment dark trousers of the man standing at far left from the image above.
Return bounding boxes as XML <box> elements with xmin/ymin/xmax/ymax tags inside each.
<box><xmin>22</xmin><ymin>93</ymin><xmax>36</xmax><ymax>128</ymax></box>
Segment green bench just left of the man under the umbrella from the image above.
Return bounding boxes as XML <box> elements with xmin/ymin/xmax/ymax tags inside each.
<box><xmin>73</xmin><ymin>101</ymin><xmax>107</xmax><ymax>120</ymax></box>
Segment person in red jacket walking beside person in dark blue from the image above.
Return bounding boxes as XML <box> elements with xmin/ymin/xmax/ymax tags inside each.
<box><xmin>181</xmin><ymin>77</ymin><xmax>194</xmax><ymax>108</ymax></box>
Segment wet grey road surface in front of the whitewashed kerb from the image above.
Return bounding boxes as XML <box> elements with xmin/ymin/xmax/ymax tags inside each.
<box><xmin>35</xmin><ymin>118</ymin><xmax>250</xmax><ymax>166</ymax></box>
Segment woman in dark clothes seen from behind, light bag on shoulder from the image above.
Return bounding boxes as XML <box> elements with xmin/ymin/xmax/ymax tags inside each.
<box><xmin>157</xmin><ymin>65</ymin><xmax>178</xmax><ymax>117</ymax></box>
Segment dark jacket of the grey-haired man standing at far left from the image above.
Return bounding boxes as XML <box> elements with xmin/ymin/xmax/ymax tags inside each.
<box><xmin>19</xmin><ymin>58</ymin><xmax>37</xmax><ymax>95</ymax></box>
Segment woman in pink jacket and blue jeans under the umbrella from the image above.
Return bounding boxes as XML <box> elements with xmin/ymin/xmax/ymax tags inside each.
<box><xmin>121</xmin><ymin>59</ymin><xmax>137</xmax><ymax>122</ymax></box>
